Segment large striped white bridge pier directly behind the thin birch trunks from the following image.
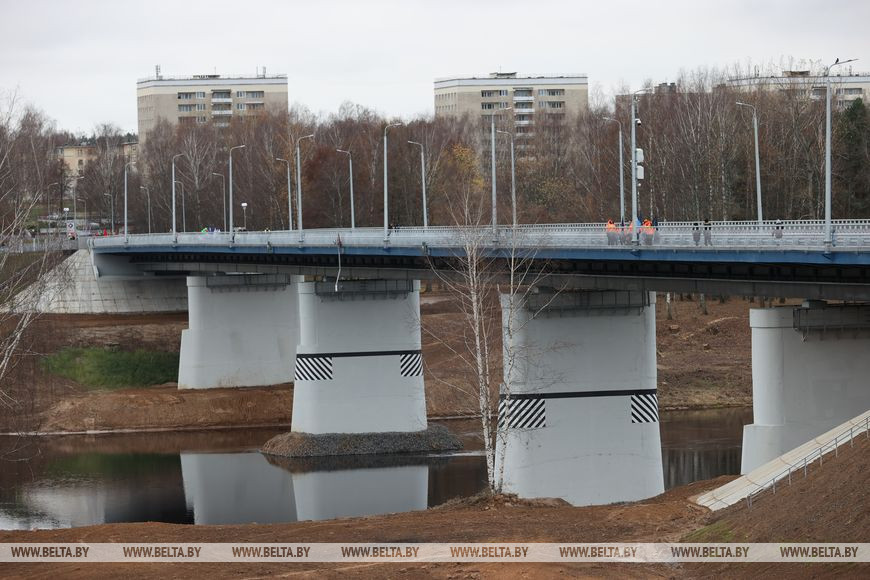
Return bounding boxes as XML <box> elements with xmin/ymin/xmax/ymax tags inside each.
<box><xmin>497</xmin><ymin>291</ymin><xmax>664</xmax><ymax>505</ymax></box>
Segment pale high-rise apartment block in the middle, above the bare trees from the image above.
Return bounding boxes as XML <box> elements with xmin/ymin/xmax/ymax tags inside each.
<box><xmin>435</xmin><ymin>72</ymin><xmax>589</xmax><ymax>135</ymax></box>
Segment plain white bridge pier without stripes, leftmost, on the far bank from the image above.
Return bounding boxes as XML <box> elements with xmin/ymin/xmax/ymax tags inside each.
<box><xmin>178</xmin><ymin>274</ymin><xmax>299</xmax><ymax>389</ymax></box>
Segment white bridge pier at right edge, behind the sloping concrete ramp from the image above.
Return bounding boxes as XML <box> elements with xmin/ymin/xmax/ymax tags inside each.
<box><xmin>740</xmin><ymin>301</ymin><xmax>870</xmax><ymax>474</ymax></box>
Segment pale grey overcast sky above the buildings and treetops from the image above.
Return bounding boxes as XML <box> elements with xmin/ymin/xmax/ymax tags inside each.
<box><xmin>0</xmin><ymin>0</ymin><xmax>870</xmax><ymax>133</ymax></box>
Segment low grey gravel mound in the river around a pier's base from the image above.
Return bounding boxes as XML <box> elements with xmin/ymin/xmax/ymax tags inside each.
<box><xmin>261</xmin><ymin>425</ymin><xmax>462</xmax><ymax>457</ymax></box>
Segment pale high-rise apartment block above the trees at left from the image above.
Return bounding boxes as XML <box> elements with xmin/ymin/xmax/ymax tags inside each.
<box><xmin>136</xmin><ymin>73</ymin><xmax>288</xmax><ymax>144</ymax></box>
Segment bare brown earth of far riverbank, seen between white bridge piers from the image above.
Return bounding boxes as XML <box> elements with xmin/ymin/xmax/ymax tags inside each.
<box><xmin>0</xmin><ymin>294</ymin><xmax>752</xmax><ymax>433</ymax></box>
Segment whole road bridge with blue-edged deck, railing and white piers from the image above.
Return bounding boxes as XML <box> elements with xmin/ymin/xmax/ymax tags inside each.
<box><xmin>80</xmin><ymin>220</ymin><xmax>870</xmax><ymax>504</ymax></box>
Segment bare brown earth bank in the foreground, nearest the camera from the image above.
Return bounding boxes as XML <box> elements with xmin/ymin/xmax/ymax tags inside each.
<box><xmin>0</xmin><ymin>438</ymin><xmax>870</xmax><ymax>579</ymax></box>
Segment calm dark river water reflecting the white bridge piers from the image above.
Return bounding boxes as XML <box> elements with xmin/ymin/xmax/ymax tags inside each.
<box><xmin>0</xmin><ymin>409</ymin><xmax>752</xmax><ymax>529</ymax></box>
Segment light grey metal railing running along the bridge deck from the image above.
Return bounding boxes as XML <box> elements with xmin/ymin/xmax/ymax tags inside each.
<box><xmin>89</xmin><ymin>220</ymin><xmax>870</xmax><ymax>251</ymax></box>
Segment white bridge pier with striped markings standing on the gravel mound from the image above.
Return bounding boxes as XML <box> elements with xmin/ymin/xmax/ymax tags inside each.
<box><xmin>293</xmin><ymin>280</ymin><xmax>427</xmax><ymax>435</ymax></box>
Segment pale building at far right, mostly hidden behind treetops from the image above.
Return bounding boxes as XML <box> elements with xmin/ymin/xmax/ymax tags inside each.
<box><xmin>728</xmin><ymin>70</ymin><xmax>870</xmax><ymax>108</ymax></box>
